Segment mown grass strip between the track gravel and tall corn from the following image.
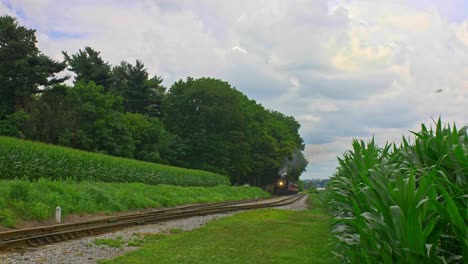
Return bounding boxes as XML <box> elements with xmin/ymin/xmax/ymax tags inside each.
<box><xmin>105</xmin><ymin>194</ymin><xmax>336</xmax><ymax>263</ymax></box>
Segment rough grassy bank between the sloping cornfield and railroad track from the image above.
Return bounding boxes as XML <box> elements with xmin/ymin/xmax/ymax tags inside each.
<box><xmin>0</xmin><ymin>179</ymin><xmax>269</xmax><ymax>227</ymax></box>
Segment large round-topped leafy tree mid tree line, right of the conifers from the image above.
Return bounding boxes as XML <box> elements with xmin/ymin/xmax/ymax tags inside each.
<box><xmin>164</xmin><ymin>78</ymin><xmax>254</xmax><ymax>177</ymax></box>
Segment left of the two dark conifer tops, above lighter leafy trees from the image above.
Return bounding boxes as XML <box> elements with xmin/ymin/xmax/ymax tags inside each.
<box><xmin>62</xmin><ymin>47</ymin><xmax>112</xmax><ymax>90</ymax></box>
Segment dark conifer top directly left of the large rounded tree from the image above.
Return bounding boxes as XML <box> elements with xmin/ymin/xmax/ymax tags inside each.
<box><xmin>111</xmin><ymin>60</ymin><xmax>165</xmax><ymax>116</ymax></box>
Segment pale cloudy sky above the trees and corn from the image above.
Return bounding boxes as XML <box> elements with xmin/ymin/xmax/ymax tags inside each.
<box><xmin>0</xmin><ymin>0</ymin><xmax>468</xmax><ymax>179</ymax></box>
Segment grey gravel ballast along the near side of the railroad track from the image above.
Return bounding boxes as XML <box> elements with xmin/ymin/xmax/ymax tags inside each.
<box><xmin>0</xmin><ymin>197</ymin><xmax>307</xmax><ymax>264</ymax></box>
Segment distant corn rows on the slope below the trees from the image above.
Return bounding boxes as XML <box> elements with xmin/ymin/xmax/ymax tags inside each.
<box><xmin>0</xmin><ymin>137</ymin><xmax>229</xmax><ymax>186</ymax></box>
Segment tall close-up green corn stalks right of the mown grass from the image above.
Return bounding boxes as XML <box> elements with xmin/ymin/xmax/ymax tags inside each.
<box><xmin>329</xmin><ymin>119</ymin><xmax>468</xmax><ymax>263</ymax></box>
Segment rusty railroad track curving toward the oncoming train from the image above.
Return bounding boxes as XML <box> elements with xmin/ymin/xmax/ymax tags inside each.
<box><xmin>0</xmin><ymin>195</ymin><xmax>303</xmax><ymax>252</ymax></box>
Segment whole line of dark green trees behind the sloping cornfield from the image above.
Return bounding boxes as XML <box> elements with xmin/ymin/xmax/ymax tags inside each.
<box><xmin>0</xmin><ymin>16</ymin><xmax>307</xmax><ymax>186</ymax></box>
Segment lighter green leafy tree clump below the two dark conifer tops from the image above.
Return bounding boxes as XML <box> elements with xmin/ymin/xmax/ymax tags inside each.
<box><xmin>26</xmin><ymin>81</ymin><xmax>177</xmax><ymax>163</ymax></box>
